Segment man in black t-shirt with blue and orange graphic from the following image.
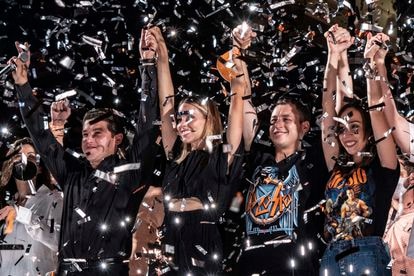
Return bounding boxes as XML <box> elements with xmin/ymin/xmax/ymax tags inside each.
<box><xmin>233</xmin><ymin>48</ymin><xmax>326</xmax><ymax>275</ymax></box>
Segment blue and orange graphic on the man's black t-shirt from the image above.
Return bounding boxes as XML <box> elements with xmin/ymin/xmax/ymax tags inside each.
<box><xmin>246</xmin><ymin>166</ymin><xmax>300</xmax><ymax>238</ymax></box>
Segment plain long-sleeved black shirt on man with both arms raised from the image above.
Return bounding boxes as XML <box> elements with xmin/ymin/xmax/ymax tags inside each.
<box><xmin>16</xmin><ymin>66</ymin><xmax>158</xmax><ymax>260</ymax></box>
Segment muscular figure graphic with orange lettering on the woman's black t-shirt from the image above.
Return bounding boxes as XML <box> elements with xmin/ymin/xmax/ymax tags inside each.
<box><xmin>324</xmin><ymin>168</ymin><xmax>374</xmax><ymax>241</ymax></box>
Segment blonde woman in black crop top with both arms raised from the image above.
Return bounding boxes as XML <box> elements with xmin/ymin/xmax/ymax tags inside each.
<box><xmin>152</xmin><ymin>26</ymin><xmax>249</xmax><ymax>275</ymax></box>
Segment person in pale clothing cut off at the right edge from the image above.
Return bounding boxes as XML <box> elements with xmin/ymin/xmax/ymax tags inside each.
<box><xmin>384</xmin><ymin>154</ymin><xmax>414</xmax><ymax>275</ymax></box>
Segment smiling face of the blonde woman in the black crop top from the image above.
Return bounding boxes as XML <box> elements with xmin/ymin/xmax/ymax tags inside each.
<box><xmin>177</xmin><ymin>103</ymin><xmax>207</xmax><ymax>149</ymax></box>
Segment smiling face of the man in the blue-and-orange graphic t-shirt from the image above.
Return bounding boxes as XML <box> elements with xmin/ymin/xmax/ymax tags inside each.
<box><xmin>269</xmin><ymin>103</ymin><xmax>309</xmax><ymax>154</ymax></box>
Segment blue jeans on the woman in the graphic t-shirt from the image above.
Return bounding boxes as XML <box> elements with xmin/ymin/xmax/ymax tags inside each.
<box><xmin>319</xmin><ymin>236</ymin><xmax>391</xmax><ymax>276</ymax></box>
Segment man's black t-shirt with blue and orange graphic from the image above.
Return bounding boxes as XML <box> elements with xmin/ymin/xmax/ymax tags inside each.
<box><xmin>246</xmin><ymin>153</ymin><xmax>309</xmax><ymax>246</ymax></box>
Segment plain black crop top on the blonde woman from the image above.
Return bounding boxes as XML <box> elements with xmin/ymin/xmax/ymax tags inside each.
<box><xmin>163</xmin><ymin>138</ymin><xmax>243</xmax><ymax>220</ymax></box>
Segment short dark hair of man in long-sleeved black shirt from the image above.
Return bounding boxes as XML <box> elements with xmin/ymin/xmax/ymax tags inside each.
<box><xmin>82</xmin><ymin>108</ymin><xmax>124</xmax><ymax>135</ymax></box>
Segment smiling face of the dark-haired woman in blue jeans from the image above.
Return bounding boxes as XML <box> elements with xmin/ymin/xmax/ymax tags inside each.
<box><xmin>338</xmin><ymin>107</ymin><xmax>368</xmax><ymax>157</ymax></box>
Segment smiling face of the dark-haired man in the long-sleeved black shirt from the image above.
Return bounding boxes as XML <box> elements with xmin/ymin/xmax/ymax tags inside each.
<box><xmin>82</xmin><ymin>120</ymin><xmax>123</xmax><ymax>168</ymax></box>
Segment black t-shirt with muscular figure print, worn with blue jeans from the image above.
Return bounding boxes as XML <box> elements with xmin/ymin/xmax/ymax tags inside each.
<box><xmin>324</xmin><ymin>158</ymin><xmax>398</xmax><ymax>241</ymax></box>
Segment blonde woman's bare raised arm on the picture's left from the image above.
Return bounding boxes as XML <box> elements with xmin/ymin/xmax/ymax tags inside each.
<box><xmin>150</xmin><ymin>27</ymin><xmax>177</xmax><ymax>158</ymax></box>
